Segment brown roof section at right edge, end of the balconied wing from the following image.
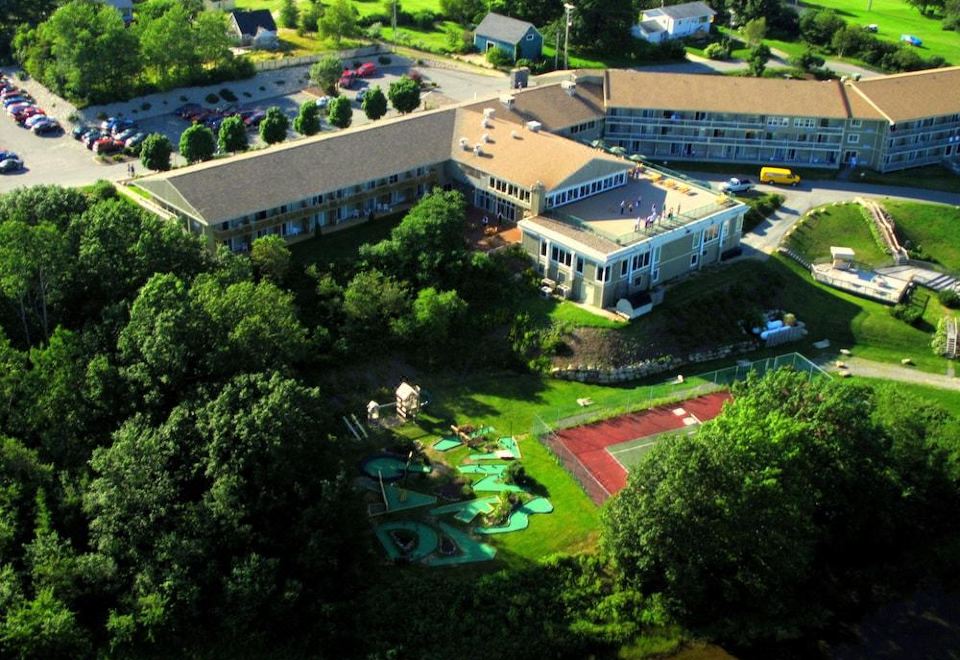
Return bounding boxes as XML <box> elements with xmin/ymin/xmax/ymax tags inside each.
<box><xmin>848</xmin><ymin>66</ymin><xmax>960</xmax><ymax>122</ymax></box>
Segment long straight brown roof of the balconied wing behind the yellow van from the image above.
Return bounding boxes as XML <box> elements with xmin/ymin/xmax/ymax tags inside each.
<box><xmin>605</xmin><ymin>69</ymin><xmax>849</xmax><ymax>119</ymax></box>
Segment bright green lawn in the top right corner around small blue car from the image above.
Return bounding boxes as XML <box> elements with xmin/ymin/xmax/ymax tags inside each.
<box><xmin>804</xmin><ymin>0</ymin><xmax>960</xmax><ymax>62</ymax></box>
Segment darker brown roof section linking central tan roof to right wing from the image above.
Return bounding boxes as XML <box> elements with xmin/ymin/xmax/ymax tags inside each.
<box><xmin>467</xmin><ymin>83</ymin><xmax>604</xmax><ymax>132</ymax></box>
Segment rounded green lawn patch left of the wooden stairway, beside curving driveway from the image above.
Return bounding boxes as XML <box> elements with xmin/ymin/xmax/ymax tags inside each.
<box><xmin>787</xmin><ymin>204</ymin><xmax>892</xmax><ymax>267</ymax></box>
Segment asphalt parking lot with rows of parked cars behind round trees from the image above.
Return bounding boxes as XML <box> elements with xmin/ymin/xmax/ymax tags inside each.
<box><xmin>0</xmin><ymin>58</ymin><xmax>507</xmax><ymax>193</ymax></box>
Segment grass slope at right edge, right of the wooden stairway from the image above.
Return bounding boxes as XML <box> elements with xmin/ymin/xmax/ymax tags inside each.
<box><xmin>883</xmin><ymin>200</ymin><xmax>960</xmax><ymax>273</ymax></box>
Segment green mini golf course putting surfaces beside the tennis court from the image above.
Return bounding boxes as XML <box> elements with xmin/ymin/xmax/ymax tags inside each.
<box><xmin>368</xmin><ymin>426</ymin><xmax>553</xmax><ymax>566</ymax></box>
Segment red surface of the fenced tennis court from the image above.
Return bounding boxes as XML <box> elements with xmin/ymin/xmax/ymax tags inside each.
<box><xmin>556</xmin><ymin>392</ymin><xmax>730</xmax><ymax>495</ymax></box>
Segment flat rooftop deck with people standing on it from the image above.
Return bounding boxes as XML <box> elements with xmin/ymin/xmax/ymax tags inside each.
<box><xmin>545</xmin><ymin>168</ymin><xmax>738</xmax><ymax>246</ymax></box>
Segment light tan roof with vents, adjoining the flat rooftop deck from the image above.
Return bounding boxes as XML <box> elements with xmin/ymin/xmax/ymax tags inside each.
<box><xmin>450</xmin><ymin>108</ymin><xmax>633</xmax><ymax>191</ymax></box>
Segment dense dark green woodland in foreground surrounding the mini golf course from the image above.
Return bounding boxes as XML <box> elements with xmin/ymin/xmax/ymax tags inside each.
<box><xmin>0</xmin><ymin>185</ymin><xmax>960</xmax><ymax>659</ymax></box>
